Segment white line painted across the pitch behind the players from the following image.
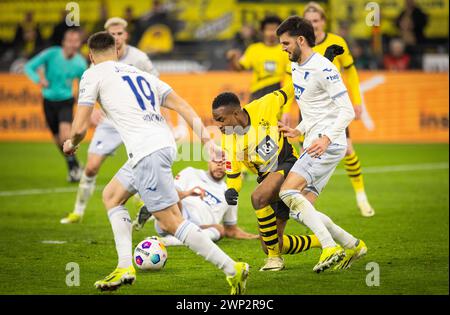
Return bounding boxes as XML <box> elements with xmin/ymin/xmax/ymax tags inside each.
<box><xmin>0</xmin><ymin>162</ymin><xmax>449</xmax><ymax>197</ymax></box>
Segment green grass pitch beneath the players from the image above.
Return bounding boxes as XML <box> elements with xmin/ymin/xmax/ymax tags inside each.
<box><xmin>0</xmin><ymin>143</ymin><xmax>449</xmax><ymax>294</ymax></box>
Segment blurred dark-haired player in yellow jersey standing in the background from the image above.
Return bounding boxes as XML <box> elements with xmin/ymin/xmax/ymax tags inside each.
<box><xmin>227</xmin><ymin>16</ymin><xmax>290</xmax><ymax>122</ymax></box>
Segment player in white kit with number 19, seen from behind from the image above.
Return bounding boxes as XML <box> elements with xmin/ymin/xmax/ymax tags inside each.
<box><xmin>64</xmin><ymin>32</ymin><xmax>249</xmax><ymax>294</ymax></box>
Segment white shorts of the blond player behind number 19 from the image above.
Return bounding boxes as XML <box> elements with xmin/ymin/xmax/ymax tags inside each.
<box><xmin>88</xmin><ymin>120</ymin><xmax>122</xmax><ymax>156</ymax></box>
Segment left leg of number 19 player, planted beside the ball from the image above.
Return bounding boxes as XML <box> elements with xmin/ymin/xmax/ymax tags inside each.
<box><xmin>94</xmin><ymin>164</ymin><xmax>136</xmax><ymax>291</ymax></box>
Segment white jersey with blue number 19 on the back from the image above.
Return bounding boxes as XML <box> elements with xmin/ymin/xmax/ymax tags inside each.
<box><xmin>78</xmin><ymin>61</ymin><xmax>176</xmax><ymax>167</ymax></box>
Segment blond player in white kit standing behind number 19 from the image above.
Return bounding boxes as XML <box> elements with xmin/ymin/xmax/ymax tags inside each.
<box><xmin>60</xmin><ymin>17</ymin><xmax>184</xmax><ymax>224</ymax></box>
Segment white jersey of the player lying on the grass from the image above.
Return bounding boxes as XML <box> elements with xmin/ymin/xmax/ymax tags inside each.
<box><xmin>175</xmin><ymin>167</ymin><xmax>237</xmax><ymax>225</ymax></box>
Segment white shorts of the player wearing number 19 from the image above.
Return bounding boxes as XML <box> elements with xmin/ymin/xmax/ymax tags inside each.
<box><xmin>115</xmin><ymin>147</ymin><xmax>179</xmax><ymax>212</ymax></box>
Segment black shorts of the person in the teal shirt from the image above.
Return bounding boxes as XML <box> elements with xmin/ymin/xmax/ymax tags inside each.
<box><xmin>44</xmin><ymin>97</ymin><xmax>74</xmax><ymax>135</ymax></box>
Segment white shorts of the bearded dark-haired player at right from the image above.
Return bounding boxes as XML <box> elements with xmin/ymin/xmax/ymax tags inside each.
<box><xmin>291</xmin><ymin>143</ymin><xmax>347</xmax><ymax>195</ymax></box>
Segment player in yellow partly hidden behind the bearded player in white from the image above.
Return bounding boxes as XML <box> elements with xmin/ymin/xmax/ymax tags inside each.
<box><xmin>303</xmin><ymin>2</ymin><xmax>375</xmax><ymax>217</ymax></box>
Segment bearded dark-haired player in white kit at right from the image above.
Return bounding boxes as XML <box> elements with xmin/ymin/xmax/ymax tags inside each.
<box><xmin>277</xmin><ymin>16</ymin><xmax>367</xmax><ymax>272</ymax></box>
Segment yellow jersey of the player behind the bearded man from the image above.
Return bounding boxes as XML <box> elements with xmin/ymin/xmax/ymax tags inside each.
<box><xmin>313</xmin><ymin>33</ymin><xmax>361</xmax><ymax>105</ymax></box>
